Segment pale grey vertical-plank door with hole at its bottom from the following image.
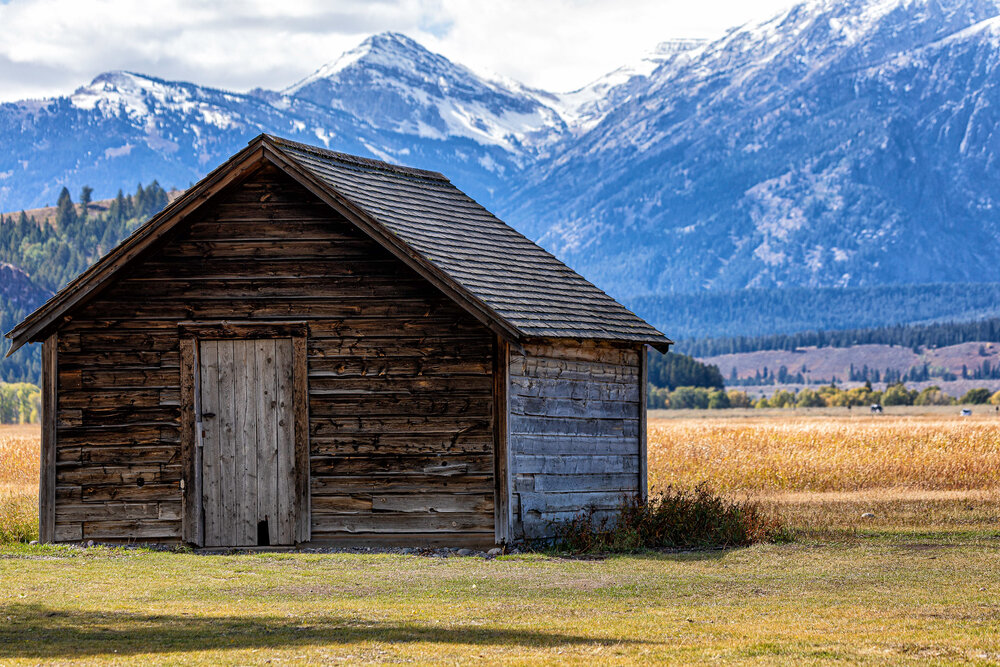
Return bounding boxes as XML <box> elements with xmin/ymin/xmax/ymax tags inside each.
<box><xmin>197</xmin><ymin>338</ymin><xmax>296</xmax><ymax>547</ymax></box>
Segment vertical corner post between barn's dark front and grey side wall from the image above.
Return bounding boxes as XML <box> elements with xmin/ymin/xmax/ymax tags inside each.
<box><xmin>493</xmin><ymin>336</ymin><xmax>511</xmax><ymax>544</ymax></box>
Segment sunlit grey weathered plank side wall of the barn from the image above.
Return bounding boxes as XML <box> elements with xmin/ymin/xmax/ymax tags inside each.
<box><xmin>509</xmin><ymin>340</ymin><xmax>644</xmax><ymax>539</ymax></box>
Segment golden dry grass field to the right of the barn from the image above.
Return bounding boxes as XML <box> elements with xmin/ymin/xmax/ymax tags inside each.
<box><xmin>649</xmin><ymin>415</ymin><xmax>1000</xmax><ymax>531</ymax></box>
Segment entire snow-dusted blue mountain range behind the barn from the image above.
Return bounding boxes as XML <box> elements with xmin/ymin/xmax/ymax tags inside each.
<box><xmin>0</xmin><ymin>0</ymin><xmax>1000</xmax><ymax>310</ymax></box>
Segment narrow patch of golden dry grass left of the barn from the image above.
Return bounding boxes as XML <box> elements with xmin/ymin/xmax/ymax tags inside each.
<box><xmin>0</xmin><ymin>425</ymin><xmax>39</xmax><ymax>543</ymax></box>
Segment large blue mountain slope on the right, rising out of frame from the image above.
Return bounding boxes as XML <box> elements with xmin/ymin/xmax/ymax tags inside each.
<box><xmin>501</xmin><ymin>0</ymin><xmax>1000</xmax><ymax>296</ymax></box>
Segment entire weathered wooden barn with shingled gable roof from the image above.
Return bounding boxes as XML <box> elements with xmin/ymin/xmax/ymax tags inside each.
<box><xmin>7</xmin><ymin>135</ymin><xmax>670</xmax><ymax>547</ymax></box>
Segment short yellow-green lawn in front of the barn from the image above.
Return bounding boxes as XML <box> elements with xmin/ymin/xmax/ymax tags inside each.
<box><xmin>0</xmin><ymin>531</ymin><xmax>1000</xmax><ymax>664</ymax></box>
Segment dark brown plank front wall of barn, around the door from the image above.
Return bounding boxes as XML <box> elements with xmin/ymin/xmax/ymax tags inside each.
<box><xmin>55</xmin><ymin>164</ymin><xmax>494</xmax><ymax>542</ymax></box>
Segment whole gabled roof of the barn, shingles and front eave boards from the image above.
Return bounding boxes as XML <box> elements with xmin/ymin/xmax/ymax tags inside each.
<box><xmin>7</xmin><ymin>135</ymin><xmax>671</xmax><ymax>354</ymax></box>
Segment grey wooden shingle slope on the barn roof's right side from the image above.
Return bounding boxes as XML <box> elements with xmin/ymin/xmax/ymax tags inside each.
<box><xmin>268</xmin><ymin>136</ymin><xmax>670</xmax><ymax>345</ymax></box>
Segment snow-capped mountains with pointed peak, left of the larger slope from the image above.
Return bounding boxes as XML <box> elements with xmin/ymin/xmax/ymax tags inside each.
<box><xmin>0</xmin><ymin>34</ymin><xmax>565</xmax><ymax>211</ymax></box>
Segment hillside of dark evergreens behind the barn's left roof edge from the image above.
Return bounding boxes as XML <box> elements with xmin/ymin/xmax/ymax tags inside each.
<box><xmin>0</xmin><ymin>181</ymin><xmax>168</xmax><ymax>383</ymax></box>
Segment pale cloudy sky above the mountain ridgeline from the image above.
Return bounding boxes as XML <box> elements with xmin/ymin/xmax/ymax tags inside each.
<box><xmin>0</xmin><ymin>0</ymin><xmax>793</xmax><ymax>101</ymax></box>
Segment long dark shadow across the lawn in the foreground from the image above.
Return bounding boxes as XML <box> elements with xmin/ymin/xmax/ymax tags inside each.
<box><xmin>0</xmin><ymin>604</ymin><xmax>656</xmax><ymax>660</ymax></box>
